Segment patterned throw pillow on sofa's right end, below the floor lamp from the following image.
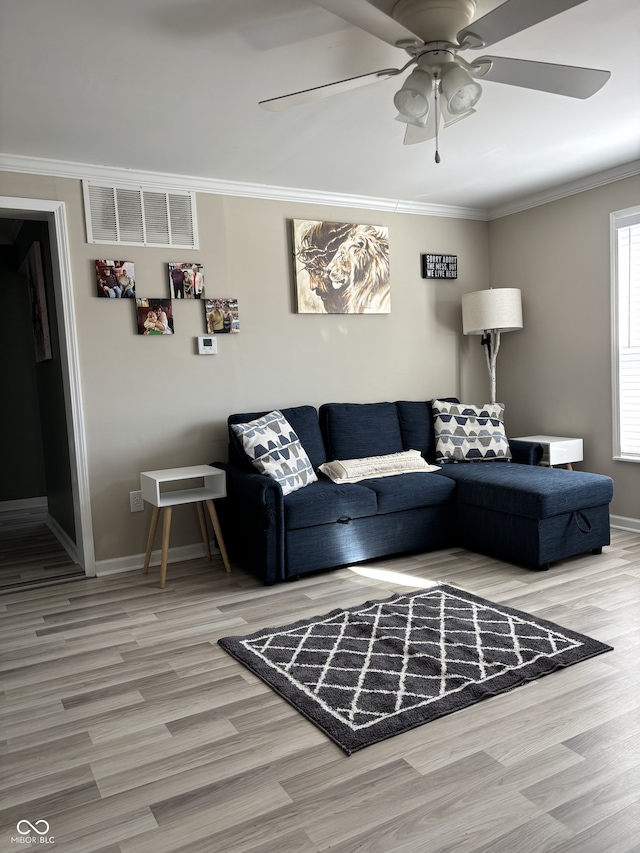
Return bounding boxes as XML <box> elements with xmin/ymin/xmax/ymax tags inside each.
<box><xmin>431</xmin><ymin>400</ymin><xmax>511</xmax><ymax>462</ymax></box>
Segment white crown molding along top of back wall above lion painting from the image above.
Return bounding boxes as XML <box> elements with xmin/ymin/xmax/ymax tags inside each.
<box><xmin>0</xmin><ymin>153</ymin><xmax>487</xmax><ymax>221</ymax></box>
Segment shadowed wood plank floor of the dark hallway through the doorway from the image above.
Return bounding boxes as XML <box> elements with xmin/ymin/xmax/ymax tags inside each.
<box><xmin>0</xmin><ymin>507</ymin><xmax>84</xmax><ymax>592</ymax></box>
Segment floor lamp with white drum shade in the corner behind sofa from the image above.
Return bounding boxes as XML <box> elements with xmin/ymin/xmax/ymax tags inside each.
<box><xmin>462</xmin><ymin>287</ymin><xmax>522</xmax><ymax>403</ymax></box>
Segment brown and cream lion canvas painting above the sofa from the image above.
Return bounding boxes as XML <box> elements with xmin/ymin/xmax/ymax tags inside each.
<box><xmin>293</xmin><ymin>219</ymin><xmax>391</xmax><ymax>314</ymax></box>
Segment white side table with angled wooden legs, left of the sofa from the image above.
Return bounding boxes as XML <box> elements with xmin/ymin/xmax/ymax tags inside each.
<box><xmin>140</xmin><ymin>465</ymin><xmax>231</xmax><ymax>589</ymax></box>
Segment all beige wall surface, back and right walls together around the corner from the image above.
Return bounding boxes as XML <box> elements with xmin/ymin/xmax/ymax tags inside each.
<box><xmin>5</xmin><ymin>172</ymin><xmax>640</xmax><ymax>562</ymax></box>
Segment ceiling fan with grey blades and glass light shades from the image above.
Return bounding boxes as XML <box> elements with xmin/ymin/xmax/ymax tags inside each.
<box><xmin>260</xmin><ymin>0</ymin><xmax>611</xmax><ymax>162</ymax></box>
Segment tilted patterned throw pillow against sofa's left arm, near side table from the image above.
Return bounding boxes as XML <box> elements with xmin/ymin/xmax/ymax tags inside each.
<box><xmin>231</xmin><ymin>411</ymin><xmax>318</xmax><ymax>495</ymax></box>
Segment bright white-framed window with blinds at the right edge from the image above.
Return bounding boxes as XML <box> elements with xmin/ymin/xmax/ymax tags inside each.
<box><xmin>611</xmin><ymin>207</ymin><xmax>640</xmax><ymax>462</ymax></box>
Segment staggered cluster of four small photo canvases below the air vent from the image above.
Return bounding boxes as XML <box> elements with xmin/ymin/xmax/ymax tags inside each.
<box><xmin>94</xmin><ymin>260</ymin><xmax>240</xmax><ymax>342</ymax></box>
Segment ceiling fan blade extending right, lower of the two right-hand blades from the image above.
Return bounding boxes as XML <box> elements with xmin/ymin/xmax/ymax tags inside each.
<box><xmin>472</xmin><ymin>56</ymin><xmax>611</xmax><ymax>98</ymax></box>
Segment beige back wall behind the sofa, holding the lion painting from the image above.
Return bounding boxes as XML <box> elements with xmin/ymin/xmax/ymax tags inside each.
<box><xmin>0</xmin><ymin>172</ymin><xmax>489</xmax><ymax>562</ymax></box>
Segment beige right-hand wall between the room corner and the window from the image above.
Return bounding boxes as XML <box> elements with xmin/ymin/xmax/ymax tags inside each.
<box><xmin>489</xmin><ymin>177</ymin><xmax>640</xmax><ymax>519</ymax></box>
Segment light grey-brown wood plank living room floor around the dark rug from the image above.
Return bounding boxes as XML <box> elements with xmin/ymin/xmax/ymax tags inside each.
<box><xmin>0</xmin><ymin>531</ymin><xmax>640</xmax><ymax>853</ymax></box>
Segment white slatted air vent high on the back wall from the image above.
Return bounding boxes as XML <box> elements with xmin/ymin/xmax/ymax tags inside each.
<box><xmin>82</xmin><ymin>181</ymin><xmax>198</xmax><ymax>249</ymax></box>
